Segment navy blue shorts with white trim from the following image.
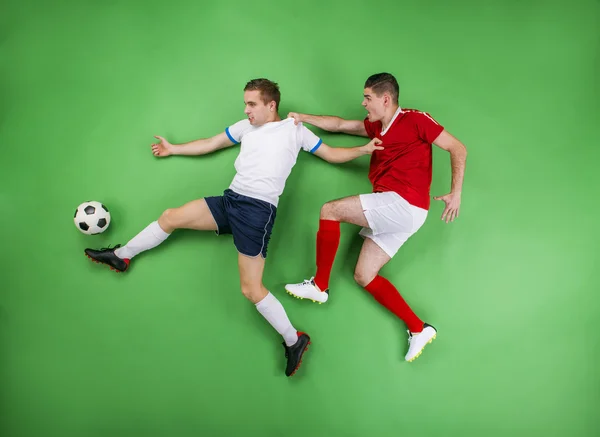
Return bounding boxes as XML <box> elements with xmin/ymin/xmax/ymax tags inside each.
<box><xmin>204</xmin><ymin>189</ymin><xmax>277</xmax><ymax>258</ymax></box>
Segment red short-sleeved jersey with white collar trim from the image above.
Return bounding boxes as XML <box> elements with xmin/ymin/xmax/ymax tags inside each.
<box><xmin>364</xmin><ymin>109</ymin><xmax>444</xmax><ymax>210</ymax></box>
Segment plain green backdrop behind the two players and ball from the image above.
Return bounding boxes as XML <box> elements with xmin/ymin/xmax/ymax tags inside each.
<box><xmin>0</xmin><ymin>0</ymin><xmax>600</xmax><ymax>437</ymax></box>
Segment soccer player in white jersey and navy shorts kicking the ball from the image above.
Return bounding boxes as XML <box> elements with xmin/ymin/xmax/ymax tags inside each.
<box><xmin>85</xmin><ymin>79</ymin><xmax>381</xmax><ymax>376</ymax></box>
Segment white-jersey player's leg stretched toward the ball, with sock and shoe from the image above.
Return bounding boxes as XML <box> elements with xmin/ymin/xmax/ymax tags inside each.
<box><xmin>85</xmin><ymin>198</ymin><xmax>218</xmax><ymax>272</ymax></box>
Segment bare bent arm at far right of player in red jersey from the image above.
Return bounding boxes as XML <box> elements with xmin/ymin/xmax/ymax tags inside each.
<box><xmin>433</xmin><ymin>130</ymin><xmax>467</xmax><ymax>223</ymax></box>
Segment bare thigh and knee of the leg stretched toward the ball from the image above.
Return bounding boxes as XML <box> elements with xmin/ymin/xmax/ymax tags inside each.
<box><xmin>158</xmin><ymin>199</ymin><xmax>217</xmax><ymax>233</ymax></box>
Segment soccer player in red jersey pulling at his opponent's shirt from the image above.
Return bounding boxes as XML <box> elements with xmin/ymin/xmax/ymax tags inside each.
<box><xmin>285</xmin><ymin>73</ymin><xmax>467</xmax><ymax>361</ymax></box>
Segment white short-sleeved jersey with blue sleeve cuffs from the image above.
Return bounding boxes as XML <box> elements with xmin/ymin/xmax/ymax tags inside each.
<box><xmin>225</xmin><ymin>118</ymin><xmax>322</xmax><ymax>207</ymax></box>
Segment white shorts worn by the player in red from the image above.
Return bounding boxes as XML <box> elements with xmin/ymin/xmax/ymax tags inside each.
<box><xmin>359</xmin><ymin>191</ymin><xmax>428</xmax><ymax>258</ymax></box>
